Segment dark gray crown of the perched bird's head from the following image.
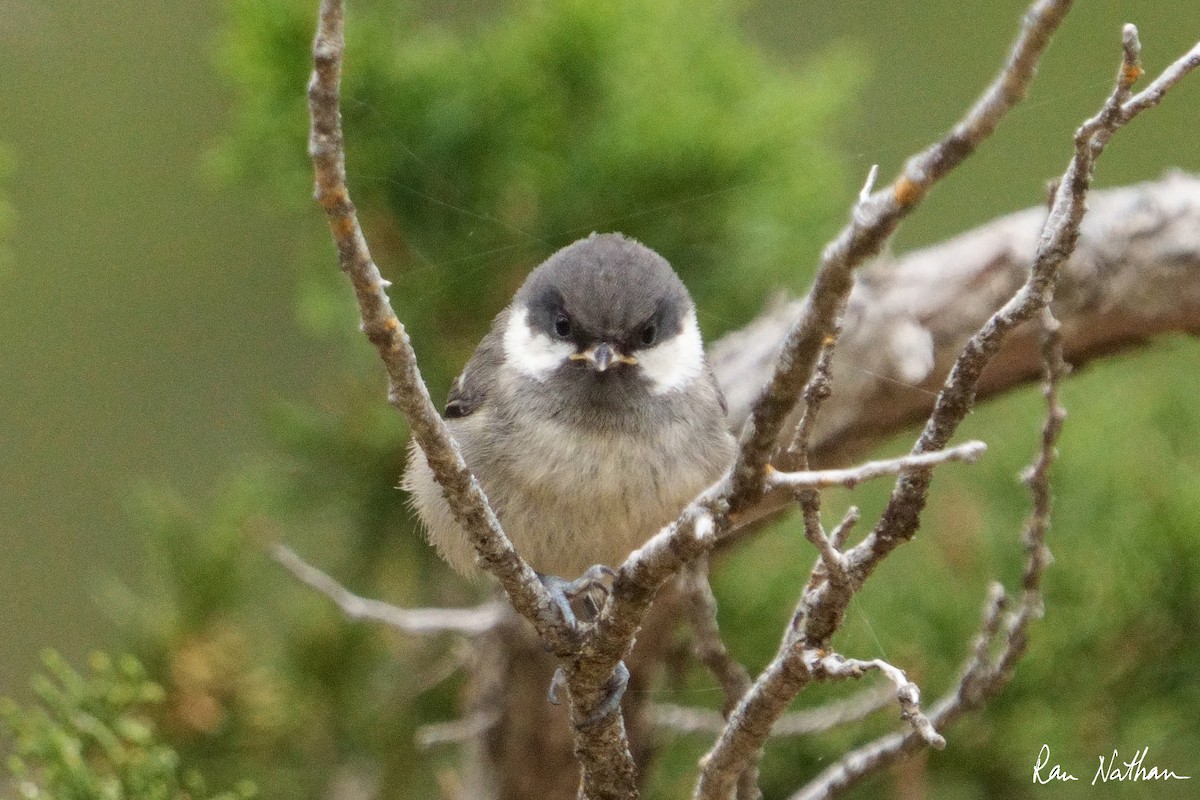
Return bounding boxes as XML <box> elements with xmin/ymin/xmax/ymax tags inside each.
<box><xmin>516</xmin><ymin>227</ymin><xmax>691</xmax><ymax>349</ymax></box>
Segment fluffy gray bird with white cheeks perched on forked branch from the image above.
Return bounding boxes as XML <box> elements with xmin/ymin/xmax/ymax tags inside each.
<box><xmin>402</xmin><ymin>233</ymin><xmax>734</xmax><ymax>594</ymax></box>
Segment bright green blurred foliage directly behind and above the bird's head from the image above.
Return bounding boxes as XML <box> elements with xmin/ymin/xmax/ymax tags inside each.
<box><xmin>218</xmin><ymin>0</ymin><xmax>859</xmax><ymax>373</ymax></box>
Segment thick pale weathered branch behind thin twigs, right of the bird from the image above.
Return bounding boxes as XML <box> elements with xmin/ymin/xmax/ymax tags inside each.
<box><xmin>709</xmin><ymin>171</ymin><xmax>1200</xmax><ymax>472</ymax></box>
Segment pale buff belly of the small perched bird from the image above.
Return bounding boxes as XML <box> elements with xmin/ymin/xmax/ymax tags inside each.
<box><xmin>403</xmin><ymin>400</ymin><xmax>734</xmax><ymax>579</ymax></box>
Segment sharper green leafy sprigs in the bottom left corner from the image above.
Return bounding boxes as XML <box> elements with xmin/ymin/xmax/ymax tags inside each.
<box><xmin>0</xmin><ymin>651</ymin><xmax>256</xmax><ymax>800</ymax></box>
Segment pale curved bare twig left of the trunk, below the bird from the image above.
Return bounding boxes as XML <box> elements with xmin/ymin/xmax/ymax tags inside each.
<box><xmin>270</xmin><ymin>545</ymin><xmax>504</xmax><ymax>636</ymax></box>
